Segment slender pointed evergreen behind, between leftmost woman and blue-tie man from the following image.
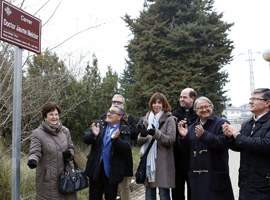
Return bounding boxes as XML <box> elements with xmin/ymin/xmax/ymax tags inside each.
<box><xmin>63</xmin><ymin>54</ymin><xmax>101</xmax><ymax>142</ymax></box>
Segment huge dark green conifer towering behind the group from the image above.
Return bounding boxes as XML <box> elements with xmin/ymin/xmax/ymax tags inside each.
<box><xmin>122</xmin><ymin>0</ymin><xmax>234</xmax><ymax>115</ymax></box>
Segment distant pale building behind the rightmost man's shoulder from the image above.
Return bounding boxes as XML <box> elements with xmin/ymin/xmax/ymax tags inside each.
<box><xmin>222</xmin><ymin>104</ymin><xmax>251</xmax><ymax>124</ymax></box>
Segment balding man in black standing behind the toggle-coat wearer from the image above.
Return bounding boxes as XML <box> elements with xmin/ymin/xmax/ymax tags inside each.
<box><xmin>172</xmin><ymin>88</ymin><xmax>198</xmax><ymax>200</ymax></box>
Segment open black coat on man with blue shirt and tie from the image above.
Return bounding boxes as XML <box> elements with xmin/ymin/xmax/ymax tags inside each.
<box><xmin>83</xmin><ymin>120</ymin><xmax>133</xmax><ymax>183</ymax></box>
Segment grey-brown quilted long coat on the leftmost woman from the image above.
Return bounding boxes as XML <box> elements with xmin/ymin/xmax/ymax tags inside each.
<box><xmin>28</xmin><ymin>122</ymin><xmax>77</xmax><ymax>200</ymax></box>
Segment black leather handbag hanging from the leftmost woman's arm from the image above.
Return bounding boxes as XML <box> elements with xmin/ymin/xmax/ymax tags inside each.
<box><xmin>59</xmin><ymin>159</ymin><xmax>88</xmax><ymax>194</ymax></box>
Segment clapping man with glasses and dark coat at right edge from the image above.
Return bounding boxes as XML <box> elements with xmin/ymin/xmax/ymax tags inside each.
<box><xmin>223</xmin><ymin>88</ymin><xmax>270</xmax><ymax>200</ymax></box>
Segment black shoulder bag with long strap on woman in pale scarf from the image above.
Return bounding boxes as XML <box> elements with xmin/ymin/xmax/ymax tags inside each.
<box><xmin>135</xmin><ymin>139</ymin><xmax>155</xmax><ymax>184</ymax></box>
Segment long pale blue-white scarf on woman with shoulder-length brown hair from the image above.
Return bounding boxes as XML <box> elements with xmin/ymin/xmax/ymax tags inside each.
<box><xmin>146</xmin><ymin>111</ymin><xmax>164</xmax><ymax>182</ymax></box>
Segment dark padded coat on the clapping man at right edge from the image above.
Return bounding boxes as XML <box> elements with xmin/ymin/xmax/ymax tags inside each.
<box><xmin>230</xmin><ymin>112</ymin><xmax>270</xmax><ymax>200</ymax></box>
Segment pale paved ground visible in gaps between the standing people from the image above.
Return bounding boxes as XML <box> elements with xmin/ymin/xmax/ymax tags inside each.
<box><xmin>131</xmin><ymin>150</ymin><xmax>239</xmax><ymax>200</ymax></box>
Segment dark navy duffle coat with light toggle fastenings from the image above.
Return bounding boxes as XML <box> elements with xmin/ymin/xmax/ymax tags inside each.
<box><xmin>180</xmin><ymin>115</ymin><xmax>234</xmax><ymax>200</ymax></box>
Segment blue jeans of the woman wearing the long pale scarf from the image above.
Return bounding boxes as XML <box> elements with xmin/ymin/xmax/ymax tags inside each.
<box><xmin>145</xmin><ymin>187</ymin><xmax>171</xmax><ymax>200</ymax></box>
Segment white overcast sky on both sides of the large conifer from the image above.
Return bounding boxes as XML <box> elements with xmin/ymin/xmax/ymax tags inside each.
<box><xmin>19</xmin><ymin>0</ymin><xmax>270</xmax><ymax>106</ymax></box>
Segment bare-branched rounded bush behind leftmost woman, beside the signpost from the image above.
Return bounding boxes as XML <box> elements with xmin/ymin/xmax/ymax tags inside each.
<box><xmin>17</xmin><ymin>51</ymin><xmax>84</xmax><ymax>148</ymax></box>
